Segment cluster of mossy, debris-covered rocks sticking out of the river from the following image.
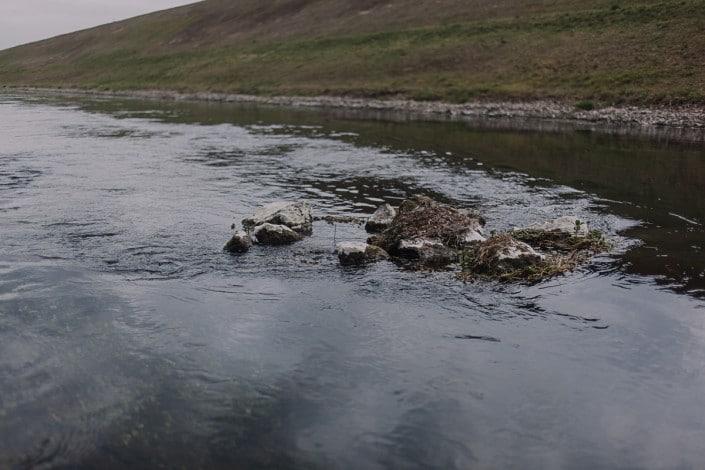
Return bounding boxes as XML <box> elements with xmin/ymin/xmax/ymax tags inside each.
<box><xmin>225</xmin><ymin>196</ymin><xmax>608</xmax><ymax>282</ymax></box>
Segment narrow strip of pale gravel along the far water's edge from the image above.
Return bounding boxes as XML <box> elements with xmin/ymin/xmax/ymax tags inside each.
<box><xmin>8</xmin><ymin>87</ymin><xmax>705</xmax><ymax>142</ymax></box>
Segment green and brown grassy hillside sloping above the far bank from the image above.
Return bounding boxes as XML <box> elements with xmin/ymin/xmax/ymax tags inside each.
<box><xmin>0</xmin><ymin>0</ymin><xmax>705</xmax><ymax>103</ymax></box>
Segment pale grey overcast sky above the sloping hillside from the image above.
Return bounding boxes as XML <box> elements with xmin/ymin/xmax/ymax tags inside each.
<box><xmin>0</xmin><ymin>0</ymin><xmax>195</xmax><ymax>50</ymax></box>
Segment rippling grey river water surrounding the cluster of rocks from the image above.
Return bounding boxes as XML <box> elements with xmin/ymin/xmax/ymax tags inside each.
<box><xmin>0</xmin><ymin>95</ymin><xmax>705</xmax><ymax>469</ymax></box>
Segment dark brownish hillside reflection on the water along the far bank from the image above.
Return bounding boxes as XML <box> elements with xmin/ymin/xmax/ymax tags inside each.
<box><xmin>64</xmin><ymin>94</ymin><xmax>705</xmax><ymax>296</ymax></box>
